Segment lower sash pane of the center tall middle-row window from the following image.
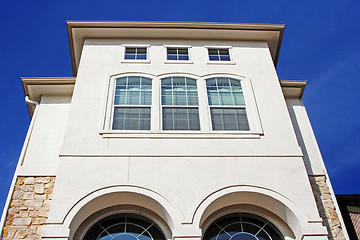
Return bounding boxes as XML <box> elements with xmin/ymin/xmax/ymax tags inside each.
<box><xmin>163</xmin><ymin>108</ymin><xmax>200</xmax><ymax>130</ymax></box>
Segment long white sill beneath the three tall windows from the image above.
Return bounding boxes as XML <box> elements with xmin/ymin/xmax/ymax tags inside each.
<box><xmin>99</xmin><ymin>130</ymin><xmax>263</xmax><ymax>139</ymax></box>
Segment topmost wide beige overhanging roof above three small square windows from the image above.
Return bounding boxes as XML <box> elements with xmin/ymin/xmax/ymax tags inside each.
<box><xmin>67</xmin><ymin>21</ymin><xmax>285</xmax><ymax>76</ymax></box>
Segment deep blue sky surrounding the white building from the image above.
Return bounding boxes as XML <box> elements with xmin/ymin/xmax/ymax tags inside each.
<box><xmin>0</xmin><ymin>0</ymin><xmax>360</xmax><ymax>218</ymax></box>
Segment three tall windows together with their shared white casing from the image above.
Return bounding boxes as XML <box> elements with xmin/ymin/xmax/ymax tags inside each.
<box><xmin>100</xmin><ymin>73</ymin><xmax>263</xmax><ymax>138</ymax></box>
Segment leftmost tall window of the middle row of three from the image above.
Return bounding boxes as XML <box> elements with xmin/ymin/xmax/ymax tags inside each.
<box><xmin>112</xmin><ymin>76</ymin><xmax>151</xmax><ymax>130</ymax></box>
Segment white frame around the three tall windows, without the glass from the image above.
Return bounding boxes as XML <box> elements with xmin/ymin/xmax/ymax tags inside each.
<box><xmin>99</xmin><ymin>72</ymin><xmax>264</xmax><ymax>139</ymax></box>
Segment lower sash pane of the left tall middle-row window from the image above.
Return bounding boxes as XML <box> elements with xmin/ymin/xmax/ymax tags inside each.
<box><xmin>113</xmin><ymin>107</ymin><xmax>150</xmax><ymax>130</ymax></box>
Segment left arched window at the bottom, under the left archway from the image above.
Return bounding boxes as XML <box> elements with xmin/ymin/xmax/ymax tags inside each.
<box><xmin>83</xmin><ymin>214</ymin><xmax>165</xmax><ymax>240</ymax></box>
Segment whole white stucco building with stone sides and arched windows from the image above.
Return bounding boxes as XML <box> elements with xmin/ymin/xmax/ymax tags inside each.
<box><xmin>2</xmin><ymin>22</ymin><xmax>348</xmax><ymax>240</ymax></box>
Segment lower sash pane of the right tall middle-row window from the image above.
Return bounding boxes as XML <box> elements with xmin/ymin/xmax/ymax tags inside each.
<box><xmin>210</xmin><ymin>108</ymin><xmax>249</xmax><ymax>130</ymax></box>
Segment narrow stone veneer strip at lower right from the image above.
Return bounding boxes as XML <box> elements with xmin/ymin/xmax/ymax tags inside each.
<box><xmin>309</xmin><ymin>176</ymin><xmax>345</xmax><ymax>240</ymax></box>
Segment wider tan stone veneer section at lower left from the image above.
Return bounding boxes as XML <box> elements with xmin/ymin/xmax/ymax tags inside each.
<box><xmin>2</xmin><ymin>177</ymin><xmax>55</xmax><ymax>240</ymax></box>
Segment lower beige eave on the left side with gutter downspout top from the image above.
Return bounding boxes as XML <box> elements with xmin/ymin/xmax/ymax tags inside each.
<box><xmin>21</xmin><ymin>77</ymin><xmax>76</xmax><ymax>117</ymax></box>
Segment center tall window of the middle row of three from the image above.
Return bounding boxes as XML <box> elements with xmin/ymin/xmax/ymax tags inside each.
<box><xmin>161</xmin><ymin>77</ymin><xmax>200</xmax><ymax>130</ymax></box>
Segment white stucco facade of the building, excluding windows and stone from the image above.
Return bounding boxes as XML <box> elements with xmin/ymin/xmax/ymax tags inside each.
<box><xmin>2</xmin><ymin>22</ymin><xmax>346</xmax><ymax>240</ymax></box>
